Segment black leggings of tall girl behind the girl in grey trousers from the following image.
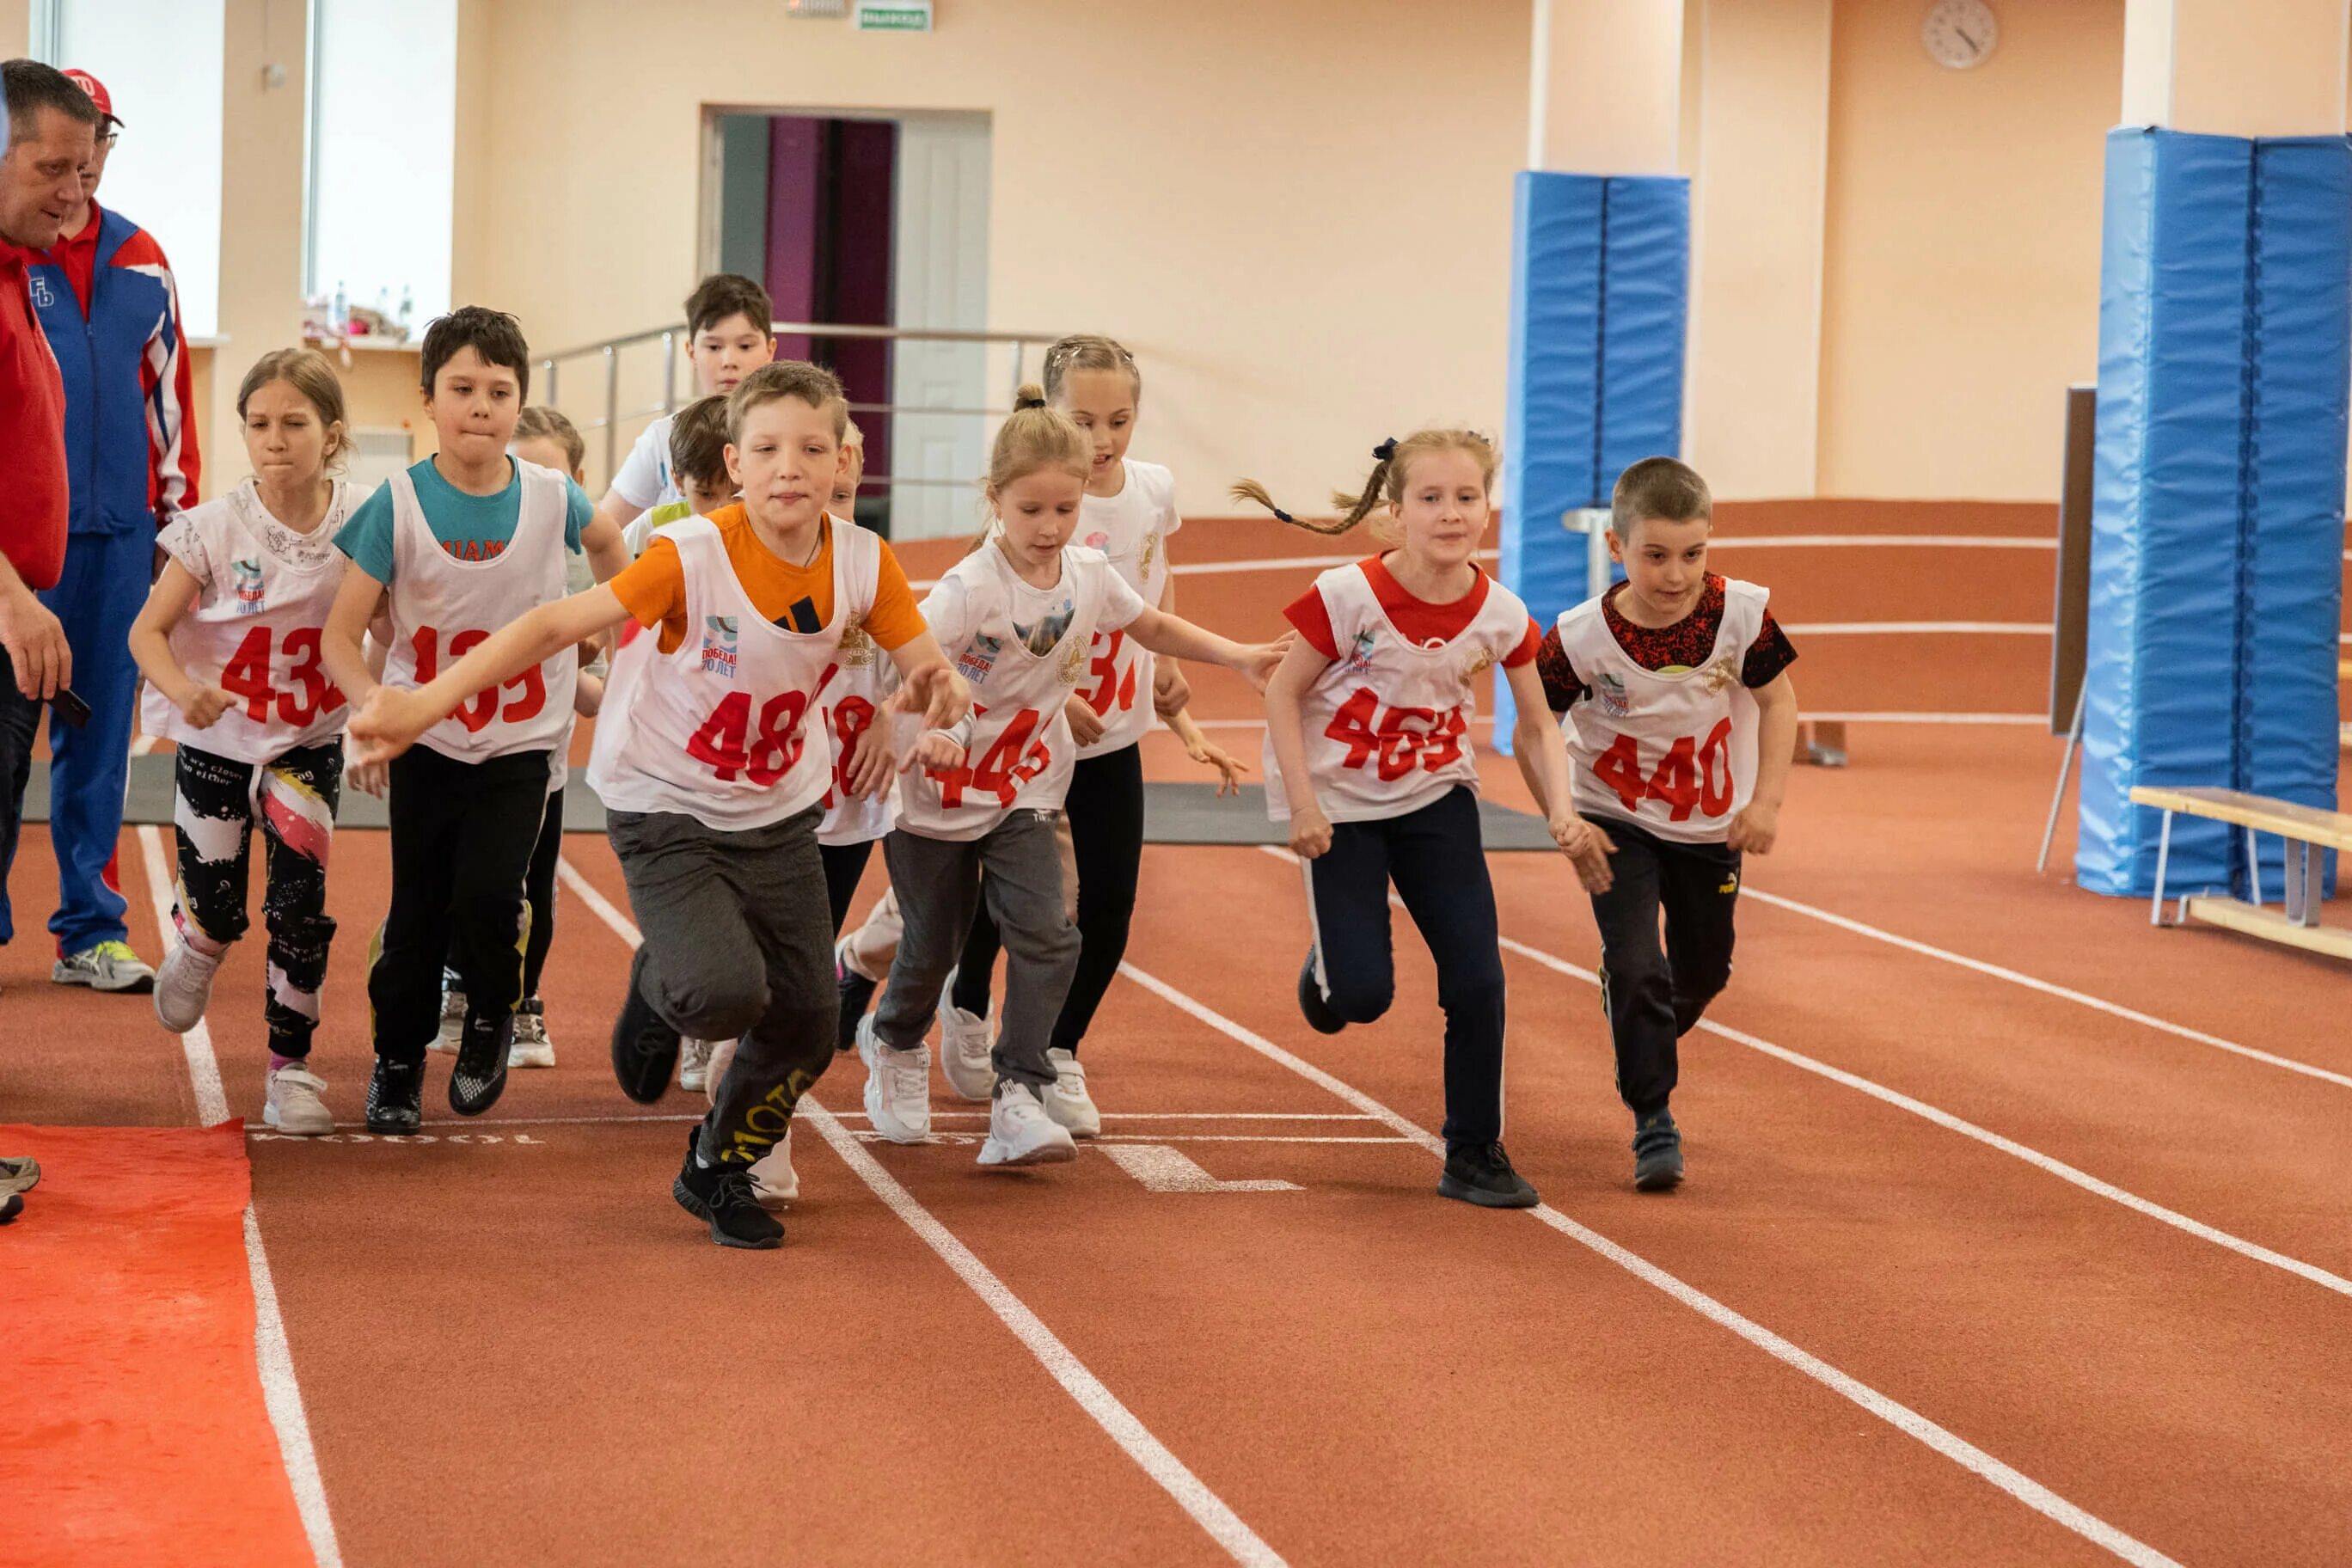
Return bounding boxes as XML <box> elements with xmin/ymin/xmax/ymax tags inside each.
<box><xmin>952</xmin><ymin>745</ymin><xmax>1143</xmax><ymax>1056</ymax></box>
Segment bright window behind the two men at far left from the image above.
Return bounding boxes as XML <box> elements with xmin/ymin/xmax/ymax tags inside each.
<box><xmin>31</xmin><ymin>0</ymin><xmax>224</xmax><ymax>339</ymax></box>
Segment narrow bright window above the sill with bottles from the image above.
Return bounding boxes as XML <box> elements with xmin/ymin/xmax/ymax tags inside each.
<box><xmin>301</xmin><ymin>0</ymin><xmax>456</xmax><ymax>329</ymax></box>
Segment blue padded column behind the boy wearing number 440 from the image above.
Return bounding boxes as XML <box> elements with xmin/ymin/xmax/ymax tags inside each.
<box><xmin>1493</xmin><ymin>172</ymin><xmax>1691</xmax><ymax>752</ymax></box>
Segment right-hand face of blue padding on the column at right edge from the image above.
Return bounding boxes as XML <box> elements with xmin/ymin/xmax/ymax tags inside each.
<box><xmin>2237</xmin><ymin>137</ymin><xmax>2352</xmax><ymax>900</ymax></box>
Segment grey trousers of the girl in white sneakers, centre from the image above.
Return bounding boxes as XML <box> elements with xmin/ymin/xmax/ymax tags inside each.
<box><xmin>875</xmin><ymin>811</ymin><xmax>1077</xmax><ymax>1088</ymax></box>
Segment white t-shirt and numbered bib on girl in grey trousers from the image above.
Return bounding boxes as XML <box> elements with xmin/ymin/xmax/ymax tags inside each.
<box><xmin>898</xmin><ymin>543</ymin><xmax>1145</xmax><ymax>842</ymax></box>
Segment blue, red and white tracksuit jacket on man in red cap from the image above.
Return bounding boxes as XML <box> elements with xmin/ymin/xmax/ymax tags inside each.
<box><xmin>28</xmin><ymin>205</ymin><xmax>198</xmax><ymax>536</ymax></box>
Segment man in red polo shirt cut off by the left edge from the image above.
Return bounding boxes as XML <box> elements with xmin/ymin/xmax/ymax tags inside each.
<box><xmin>0</xmin><ymin>58</ymin><xmax>99</xmax><ymax>1222</ymax></box>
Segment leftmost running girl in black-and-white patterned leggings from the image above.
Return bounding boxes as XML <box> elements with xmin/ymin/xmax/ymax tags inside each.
<box><xmin>129</xmin><ymin>348</ymin><xmax>358</xmax><ymax>1138</ymax></box>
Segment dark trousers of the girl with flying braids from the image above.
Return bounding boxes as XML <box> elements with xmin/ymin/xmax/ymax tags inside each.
<box><xmin>1305</xmin><ymin>785</ymin><xmax>1503</xmax><ymax>1145</ymax></box>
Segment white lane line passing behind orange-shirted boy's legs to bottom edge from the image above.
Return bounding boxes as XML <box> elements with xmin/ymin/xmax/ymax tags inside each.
<box><xmin>555</xmin><ymin>858</ymin><xmax>1282</xmax><ymax>1568</ymax></box>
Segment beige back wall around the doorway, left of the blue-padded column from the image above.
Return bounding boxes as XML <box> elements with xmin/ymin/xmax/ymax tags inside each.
<box><xmin>454</xmin><ymin>0</ymin><xmax>1528</xmax><ymax>512</ymax></box>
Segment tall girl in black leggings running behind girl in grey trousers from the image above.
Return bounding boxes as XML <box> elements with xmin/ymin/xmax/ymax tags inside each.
<box><xmin>842</xmin><ymin>336</ymin><xmax>1240</xmax><ymax>1138</ymax></box>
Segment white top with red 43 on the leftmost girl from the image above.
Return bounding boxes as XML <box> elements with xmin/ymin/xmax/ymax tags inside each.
<box><xmin>138</xmin><ymin>480</ymin><xmax>360</xmax><ymax>762</ymax></box>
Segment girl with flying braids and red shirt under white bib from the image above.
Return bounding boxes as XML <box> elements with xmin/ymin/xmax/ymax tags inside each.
<box><xmin>1233</xmin><ymin>430</ymin><xmax>1602</xmax><ymax>1209</ymax></box>
